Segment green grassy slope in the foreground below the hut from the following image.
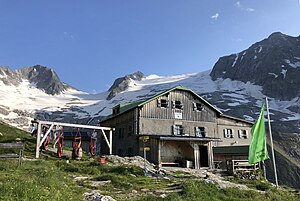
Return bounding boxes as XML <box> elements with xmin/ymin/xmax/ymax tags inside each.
<box><xmin>0</xmin><ymin>123</ymin><xmax>300</xmax><ymax>200</ymax></box>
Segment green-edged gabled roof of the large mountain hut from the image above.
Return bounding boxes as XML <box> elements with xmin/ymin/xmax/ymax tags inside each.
<box><xmin>114</xmin><ymin>86</ymin><xmax>222</xmax><ymax>114</ymax></box>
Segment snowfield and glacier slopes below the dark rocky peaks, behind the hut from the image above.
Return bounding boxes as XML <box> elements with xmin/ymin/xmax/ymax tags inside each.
<box><xmin>0</xmin><ymin>64</ymin><xmax>300</xmax><ymax>131</ymax></box>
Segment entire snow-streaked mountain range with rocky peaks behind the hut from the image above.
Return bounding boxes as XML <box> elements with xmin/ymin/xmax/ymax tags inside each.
<box><xmin>0</xmin><ymin>33</ymin><xmax>300</xmax><ymax>155</ymax></box>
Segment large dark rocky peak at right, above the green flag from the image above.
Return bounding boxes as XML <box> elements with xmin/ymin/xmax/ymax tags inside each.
<box><xmin>210</xmin><ymin>32</ymin><xmax>300</xmax><ymax>100</ymax></box>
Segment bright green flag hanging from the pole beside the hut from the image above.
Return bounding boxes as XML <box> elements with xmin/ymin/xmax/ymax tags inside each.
<box><xmin>248</xmin><ymin>104</ymin><xmax>269</xmax><ymax>164</ymax></box>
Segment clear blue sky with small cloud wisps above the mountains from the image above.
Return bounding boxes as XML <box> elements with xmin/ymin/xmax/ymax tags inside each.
<box><xmin>0</xmin><ymin>0</ymin><xmax>300</xmax><ymax>93</ymax></box>
